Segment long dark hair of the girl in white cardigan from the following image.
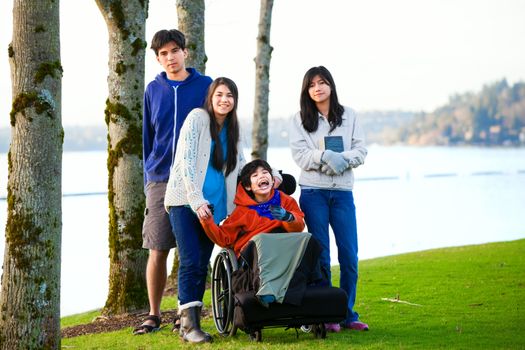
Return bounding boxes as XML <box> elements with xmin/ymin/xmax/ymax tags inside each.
<box><xmin>204</xmin><ymin>77</ymin><xmax>239</xmax><ymax>176</ymax></box>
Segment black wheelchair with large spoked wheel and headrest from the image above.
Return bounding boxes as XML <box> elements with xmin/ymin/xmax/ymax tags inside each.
<box><xmin>211</xmin><ymin>173</ymin><xmax>348</xmax><ymax>342</ymax></box>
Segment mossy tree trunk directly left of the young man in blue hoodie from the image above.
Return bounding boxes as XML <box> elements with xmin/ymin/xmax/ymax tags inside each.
<box><xmin>96</xmin><ymin>0</ymin><xmax>148</xmax><ymax>315</ymax></box>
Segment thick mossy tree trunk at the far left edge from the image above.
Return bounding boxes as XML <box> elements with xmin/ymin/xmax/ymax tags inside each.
<box><xmin>0</xmin><ymin>0</ymin><xmax>64</xmax><ymax>350</ymax></box>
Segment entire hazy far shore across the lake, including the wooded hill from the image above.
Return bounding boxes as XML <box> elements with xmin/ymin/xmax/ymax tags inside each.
<box><xmin>0</xmin><ymin>79</ymin><xmax>525</xmax><ymax>153</ymax></box>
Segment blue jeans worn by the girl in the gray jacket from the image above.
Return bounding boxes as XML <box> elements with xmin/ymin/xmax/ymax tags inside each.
<box><xmin>299</xmin><ymin>188</ymin><xmax>359</xmax><ymax>323</ymax></box>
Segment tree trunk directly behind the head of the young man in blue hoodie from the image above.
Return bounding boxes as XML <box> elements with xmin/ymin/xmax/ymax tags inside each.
<box><xmin>177</xmin><ymin>0</ymin><xmax>208</xmax><ymax>74</ymax></box>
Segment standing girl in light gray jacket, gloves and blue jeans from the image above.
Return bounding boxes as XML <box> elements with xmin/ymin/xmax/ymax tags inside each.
<box><xmin>290</xmin><ymin>66</ymin><xmax>368</xmax><ymax>332</ymax></box>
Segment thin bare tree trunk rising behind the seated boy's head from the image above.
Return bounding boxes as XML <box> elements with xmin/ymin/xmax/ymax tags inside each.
<box><xmin>252</xmin><ymin>0</ymin><xmax>273</xmax><ymax>160</ymax></box>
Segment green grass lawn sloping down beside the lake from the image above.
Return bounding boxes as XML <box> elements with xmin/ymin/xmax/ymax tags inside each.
<box><xmin>62</xmin><ymin>240</ymin><xmax>525</xmax><ymax>349</ymax></box>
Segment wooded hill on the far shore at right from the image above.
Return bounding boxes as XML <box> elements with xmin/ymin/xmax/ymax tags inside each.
<box><xmin>393</xmin><ymin>79</ymin><xmax>525</xmax><ymax>146</ymax></box>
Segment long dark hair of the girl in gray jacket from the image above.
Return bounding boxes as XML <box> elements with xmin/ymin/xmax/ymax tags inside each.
<box><xmin>300</xmin><ymin>66</ymin><xmax>345</xmax><ymax>132</ymax></box>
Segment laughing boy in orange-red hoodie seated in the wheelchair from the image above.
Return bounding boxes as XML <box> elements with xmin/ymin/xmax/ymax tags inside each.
<box><xmin>201</xmin><ymin>159</ymin><xmax>327</xmax><ymax>307</ymax></box>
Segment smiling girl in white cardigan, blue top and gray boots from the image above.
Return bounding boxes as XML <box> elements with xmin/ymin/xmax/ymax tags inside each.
<box><xmin>164</xmin><ymin>77</ymin><xmax>246</xmax><ymax>343</ymax></box>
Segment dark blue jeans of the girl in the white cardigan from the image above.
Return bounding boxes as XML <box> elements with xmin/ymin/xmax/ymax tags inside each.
<box><xmin>170</xmin><ymin>206</ymin><xmax>213</xmax><ymax>305</ymax></box>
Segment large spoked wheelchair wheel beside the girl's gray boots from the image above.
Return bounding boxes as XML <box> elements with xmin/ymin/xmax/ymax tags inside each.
<box><xmin>211</xmin><ymin>249</ymin><xmax>237</xmax><ymax>336</ymax></box>
